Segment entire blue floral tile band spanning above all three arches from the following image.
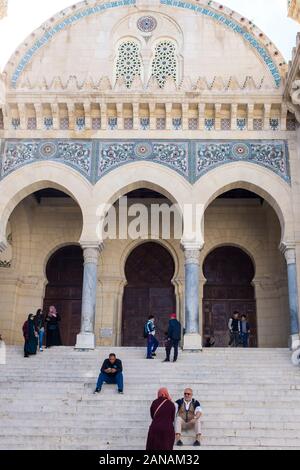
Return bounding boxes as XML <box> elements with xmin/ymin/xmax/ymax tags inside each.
<box><xmin>0</xmin><ymin>139</ymin><xmax>290</xmax><ymax>184</ymax></box>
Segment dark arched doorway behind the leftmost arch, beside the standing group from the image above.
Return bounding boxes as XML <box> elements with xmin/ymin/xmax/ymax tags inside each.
<box><xmin>44</xmin><ymin>246</ymin><xmax>84</xmax><ymax>346</ymax></box>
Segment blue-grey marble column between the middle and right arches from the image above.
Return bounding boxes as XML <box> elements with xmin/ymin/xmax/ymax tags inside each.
<box><xmin>183</xmin><ymin>246</ymin><xmax>202</xmax><ymax>351</ymax></box>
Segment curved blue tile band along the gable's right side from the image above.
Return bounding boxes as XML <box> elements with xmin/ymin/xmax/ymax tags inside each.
<box><xmin>160</xmin><ymin>0</ymin><xmax>281</xmax><ymax>87</ymax></box>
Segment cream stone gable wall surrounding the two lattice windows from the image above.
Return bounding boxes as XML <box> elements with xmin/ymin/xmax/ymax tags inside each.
<box><xmin>7</xmin><ymin>0</ymin><xmax>274</xmax><ymax>87</ymax></box>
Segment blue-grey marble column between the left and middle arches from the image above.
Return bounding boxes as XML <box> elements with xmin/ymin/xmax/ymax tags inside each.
<box><xmin>75</xmin><ymin>245</ymin><xmax>101</xmax><ymax>349</ymax></box>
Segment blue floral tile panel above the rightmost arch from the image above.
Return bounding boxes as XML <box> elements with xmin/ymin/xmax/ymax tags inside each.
<box><xmin>196</xmin><ymin>141</ymin><xmax>290</xmax><ymax>183</ymax></box>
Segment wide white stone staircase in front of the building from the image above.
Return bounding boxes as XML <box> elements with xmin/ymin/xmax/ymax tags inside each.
<box><xmin>0</xmin><ymin>347</ymin><xmax>300</xmax><ymax>450</ymax></box>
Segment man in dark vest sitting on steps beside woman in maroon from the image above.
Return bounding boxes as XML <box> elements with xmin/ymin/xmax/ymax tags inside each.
<box><xmin>175</xmin><ymin>388</ymin><xmax>202</xmax><ymax>447</ymax></box>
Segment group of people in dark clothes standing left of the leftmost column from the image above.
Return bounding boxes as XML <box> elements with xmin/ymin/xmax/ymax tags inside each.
<box><xmin>23</xmin><ymin>305</ymin><xmax>62</xmax><ymax>357</ymax></box>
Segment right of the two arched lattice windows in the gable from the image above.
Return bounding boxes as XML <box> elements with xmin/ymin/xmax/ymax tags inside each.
<box><xmin>152</xmin><ymin>40</ymin><xmax>178</xmax><ymax>88</ymax></box>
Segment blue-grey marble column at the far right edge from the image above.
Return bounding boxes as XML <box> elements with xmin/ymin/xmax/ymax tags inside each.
<box><xmin>282</xmin><ymin>245</ymin><xmax>300</xmax><ymax>351</ymax></box>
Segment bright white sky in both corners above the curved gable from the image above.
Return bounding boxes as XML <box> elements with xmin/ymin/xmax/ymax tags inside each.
<box><xmin>0</xmin><ymin>0</ymin><xmax>300</xmax><ymax>70</ymax></box>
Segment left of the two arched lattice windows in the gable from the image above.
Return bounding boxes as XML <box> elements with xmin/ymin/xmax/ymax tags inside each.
<box><xmin>116</xmin><ymin>41</ymin><xmax>142</xmax><ymax>88</ymax></box>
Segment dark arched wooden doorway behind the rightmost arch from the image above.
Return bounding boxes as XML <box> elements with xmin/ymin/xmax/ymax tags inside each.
<box><xmin>203</xmin><ymin>246</ymin><xmax>257</xmax><ymax>348</ymax></box>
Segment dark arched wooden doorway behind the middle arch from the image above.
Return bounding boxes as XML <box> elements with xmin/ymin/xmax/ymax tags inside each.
<box><xmin>122</xmin><ymin>242</ymin><xmax>176</xmax><ymax>346</ymax></box>
